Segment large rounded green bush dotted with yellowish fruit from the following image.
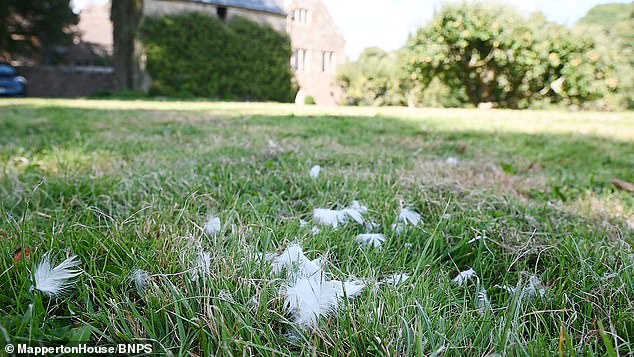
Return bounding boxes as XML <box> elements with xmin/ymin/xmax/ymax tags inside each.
<box><xmin>409</xmin><ymin>3</ymin><xmax>617</xmax><ymax>108</ymax></box>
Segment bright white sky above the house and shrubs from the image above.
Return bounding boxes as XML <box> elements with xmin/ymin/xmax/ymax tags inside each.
<box><xmin>73</xmin><ymin>0</ymin><xmax>631</xmax><ymax>60</ymax></box>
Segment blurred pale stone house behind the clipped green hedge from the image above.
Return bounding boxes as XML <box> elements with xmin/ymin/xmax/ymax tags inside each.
<box><xmin>78</xmin><ymin>0</ymin><xmax>345</xmax><ymax>105</ymax></box>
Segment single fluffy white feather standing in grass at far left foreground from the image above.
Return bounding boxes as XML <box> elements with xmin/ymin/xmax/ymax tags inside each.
<box><xmin>33</xmin><ymin>255</ymin><xmax>82</xmax><ymax>297</ymax></box>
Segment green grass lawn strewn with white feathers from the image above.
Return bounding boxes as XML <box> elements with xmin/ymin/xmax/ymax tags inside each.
<box><xmin>0</xmin><ymin>99</ymin><xmax>634</xmax><ymax>356</ymax></box>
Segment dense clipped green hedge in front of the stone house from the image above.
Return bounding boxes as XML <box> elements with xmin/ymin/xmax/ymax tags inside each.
<box><xmin>141</xmin><ymin>13</ymin><xmax>297</xmax><ymax>102</ymax></box>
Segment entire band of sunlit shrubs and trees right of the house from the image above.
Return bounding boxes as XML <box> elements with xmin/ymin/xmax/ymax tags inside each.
<box><xmin>338</xmin><ymin>3</ymin><xmax>634</xmax><ymax>110</ymax></box>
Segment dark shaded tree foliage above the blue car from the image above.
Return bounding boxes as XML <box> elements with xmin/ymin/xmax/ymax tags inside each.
<box><xmin>0</xmin><ymin>0</ymin><xmax>77</xmax><ymax>63</ymax></box>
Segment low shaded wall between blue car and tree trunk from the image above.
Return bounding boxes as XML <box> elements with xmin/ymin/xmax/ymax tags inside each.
<box><xmin>17</xmin><ymin>66</ymin><xmax>116</xmax><ymax>98</ymax></box>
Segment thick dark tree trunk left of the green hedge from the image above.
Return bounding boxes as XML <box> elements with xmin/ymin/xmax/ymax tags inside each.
<box><xmin>110</xmin><ymin>0</ymin><xmax>149</xmax><ymax>91</ymax></box>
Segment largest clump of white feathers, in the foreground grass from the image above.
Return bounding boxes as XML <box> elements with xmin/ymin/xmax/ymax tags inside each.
<box><xmin>270</xmin><ymin>244</ymin><xmax>365</xmax><ymax>329</ymax></box>
